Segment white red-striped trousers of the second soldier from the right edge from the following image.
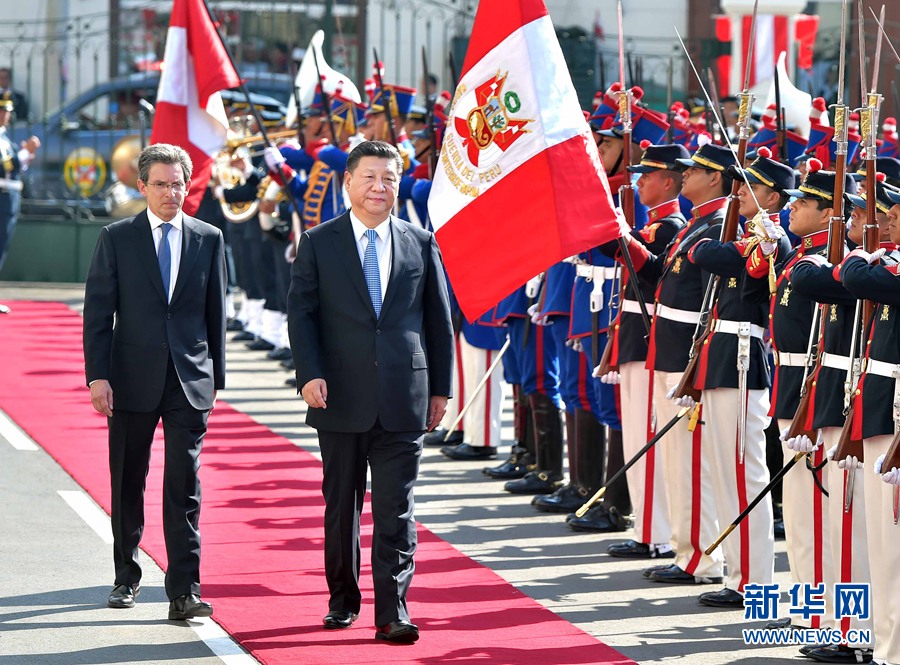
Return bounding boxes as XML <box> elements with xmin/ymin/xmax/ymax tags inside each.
<box><xmin>824</xmin><ymin>427</ymin><xmax>875</xmax><ymax>647</ymax></box>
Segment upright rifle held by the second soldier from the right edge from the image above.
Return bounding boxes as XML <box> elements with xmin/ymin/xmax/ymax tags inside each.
<box><xmin>834</xmin><ymin>1</ymin><xmax>881</xmax><ymax>472</ymax></box>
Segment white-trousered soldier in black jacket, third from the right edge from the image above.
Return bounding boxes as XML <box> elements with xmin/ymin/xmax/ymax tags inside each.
<box><xmin>745</xmin><ymin>159</ymin><xmax>857</xmax><ymax>628</ymax></box>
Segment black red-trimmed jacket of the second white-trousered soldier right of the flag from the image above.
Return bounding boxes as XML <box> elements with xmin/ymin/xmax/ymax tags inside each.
<box><xmin>629</xmin><ymin>197</ymin><xmax>727</xmax><ymax>372</ymax></box>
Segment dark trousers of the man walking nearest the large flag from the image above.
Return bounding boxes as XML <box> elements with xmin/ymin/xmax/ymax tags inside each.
<box><xmin>319</xmin><ymin>422</ymin><xmax>422</xmax><ymax>627</ymax></box>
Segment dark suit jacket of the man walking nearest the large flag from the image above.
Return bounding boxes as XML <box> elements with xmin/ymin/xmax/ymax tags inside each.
<box><xmin>287</xmin><ymin>212</ymin><xmax>453</xmax><ymax>432</ymax></box>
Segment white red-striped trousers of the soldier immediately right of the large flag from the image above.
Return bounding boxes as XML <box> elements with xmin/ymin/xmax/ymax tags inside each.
<box><xmin>619</xmin><ymin>361</ymin><xmax>672</xmax><ymax>545</ymax></box>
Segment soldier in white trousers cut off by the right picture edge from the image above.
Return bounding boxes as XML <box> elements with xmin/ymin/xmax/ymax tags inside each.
<box><xmin>840</xmin><ymin>185</ymin><xmax>900</xmax><ymax>663</ymax></box>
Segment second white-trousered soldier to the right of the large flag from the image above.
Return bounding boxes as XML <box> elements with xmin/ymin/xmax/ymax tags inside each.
<box><xmin>625</xmin><ymin>143</ymin><xmax>734</xmax><ymax>584</ymax></box>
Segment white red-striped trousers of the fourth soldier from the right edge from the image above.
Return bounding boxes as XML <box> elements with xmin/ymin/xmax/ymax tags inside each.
<box><xmin>702</xmin><ymin>388</ymin><xmax>775</xmax><ymax>593</ymax></box>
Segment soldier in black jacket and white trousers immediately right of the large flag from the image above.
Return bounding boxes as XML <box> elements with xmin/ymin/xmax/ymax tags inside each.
<box><xmin>597</xmin><ymin>140</ymin><xmax>690</xmax><ymax>559</ymax></box>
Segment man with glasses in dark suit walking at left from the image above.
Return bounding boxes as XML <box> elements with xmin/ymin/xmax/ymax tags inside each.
<box><xmin>84</xmin><ymin>143</ymin><xmax>225</xmax><ymax>619</ymax></box>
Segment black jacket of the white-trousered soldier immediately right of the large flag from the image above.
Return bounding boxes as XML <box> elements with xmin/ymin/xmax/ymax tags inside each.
<box><xmin>601</xmin><ymin>199</ymin><xmax>686</xmax><ymax>365</ymax></box>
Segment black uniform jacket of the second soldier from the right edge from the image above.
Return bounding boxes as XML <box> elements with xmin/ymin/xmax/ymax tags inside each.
<box><xmin>791</xmin><ymin>246</ymin><xmax>857</xmax><ymax>429</ymax></box>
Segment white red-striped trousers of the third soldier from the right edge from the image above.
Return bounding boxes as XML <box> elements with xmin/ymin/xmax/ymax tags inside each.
<box><xmin>778</xmin><ymin>418</ymin><xmax>836</xmax><ymax>628</ymax></box>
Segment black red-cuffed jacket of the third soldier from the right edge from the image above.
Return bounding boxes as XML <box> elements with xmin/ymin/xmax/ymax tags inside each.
<box><xmin>743</xmin><ymin>231</ymin><xmax>828</xmax><ymax>420</ymax></box>
